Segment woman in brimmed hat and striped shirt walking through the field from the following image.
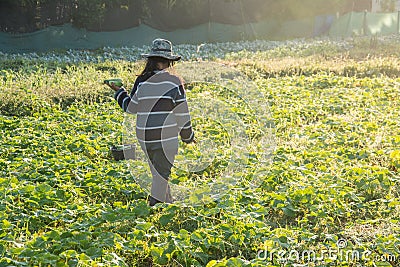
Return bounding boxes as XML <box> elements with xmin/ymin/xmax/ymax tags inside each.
<box><xmin>106</xmin><ymin>39</ymin><xmax>195</xmax><ymax>206</ymax></box>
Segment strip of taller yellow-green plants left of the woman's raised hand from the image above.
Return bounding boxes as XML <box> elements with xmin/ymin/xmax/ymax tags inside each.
<box><xmin>0</xmin><ymin>60</ymin><xmax>142</xmax><ymax>116</ymax></box>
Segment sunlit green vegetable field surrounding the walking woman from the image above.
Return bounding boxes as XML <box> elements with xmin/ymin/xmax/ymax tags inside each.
<box><xmin>0</xmin><ymin>37</ymin><xmax>400</xmax><ymax>267</ymax></box>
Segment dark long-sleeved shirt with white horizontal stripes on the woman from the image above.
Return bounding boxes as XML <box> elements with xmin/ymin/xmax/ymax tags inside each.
<box><xmin>115</xmin><ymin>70</ymin><xmax>194</xmax><ymax>149</ymax></box>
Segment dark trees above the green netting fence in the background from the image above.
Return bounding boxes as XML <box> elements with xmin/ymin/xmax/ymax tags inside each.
<box><xmin>0</xmin><ymin>0</ymin><xmax>371</xmax><ymax>32</ymax></box>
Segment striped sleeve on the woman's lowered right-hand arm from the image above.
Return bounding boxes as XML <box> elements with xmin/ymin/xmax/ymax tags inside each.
<box><xmin>174</xmin><ymin>85</ymin><xmax>194</xmax><ymax>143</ymax></box>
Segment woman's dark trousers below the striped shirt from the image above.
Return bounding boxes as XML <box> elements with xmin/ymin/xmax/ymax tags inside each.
<box><xmin>146</xmin><ymin>148</ymin><xmax>177</xmax><ymax>203</ymax></box>
